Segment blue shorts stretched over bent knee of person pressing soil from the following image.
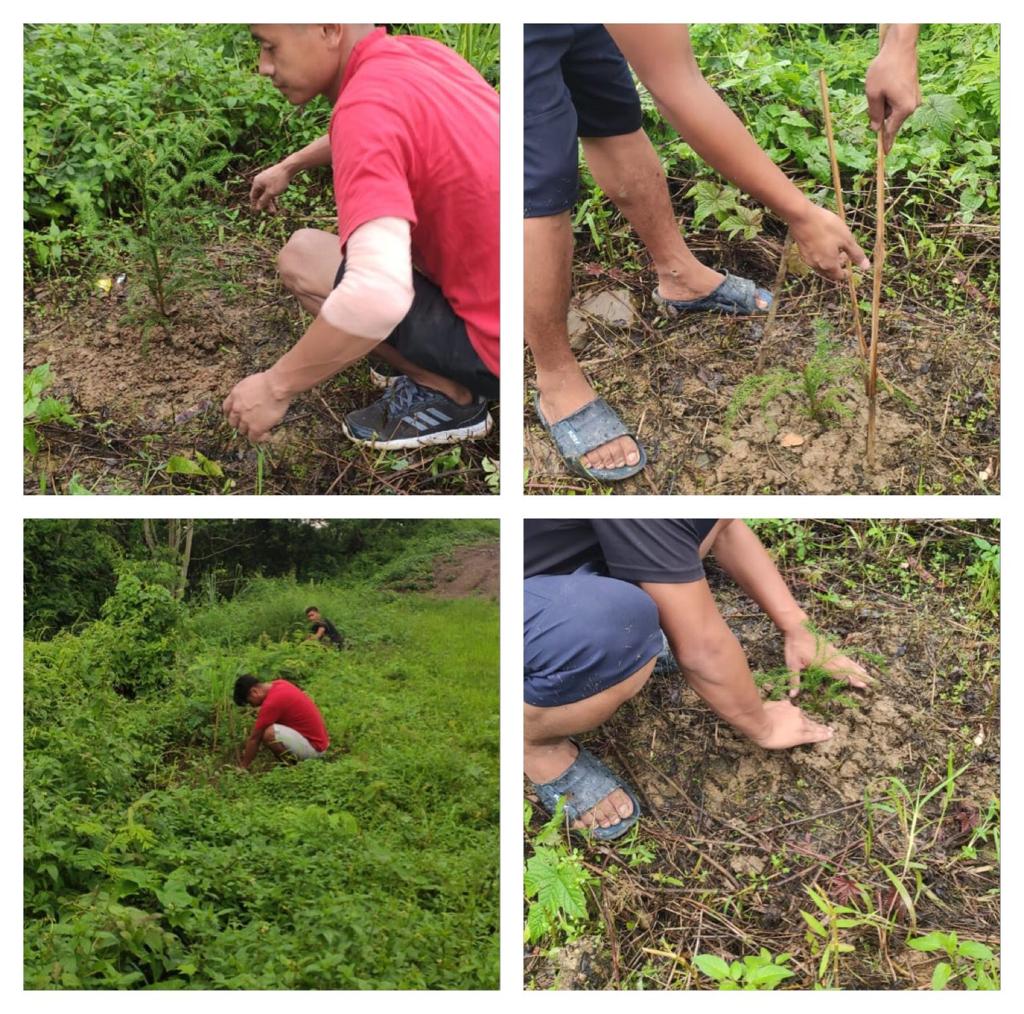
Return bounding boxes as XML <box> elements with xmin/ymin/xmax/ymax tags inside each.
<box><xmin>523</xmin><ymin>564</ymin><xmax>665</xmax><ymax>708</ymax></box>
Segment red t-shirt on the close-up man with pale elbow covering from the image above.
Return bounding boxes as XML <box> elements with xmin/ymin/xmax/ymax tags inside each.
<box><xmin>330</xmin><ymin>29</ymin><xmax>500</xmax><ymax>376</ymax></box>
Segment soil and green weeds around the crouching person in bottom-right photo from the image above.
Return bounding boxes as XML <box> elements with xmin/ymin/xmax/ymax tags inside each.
<box><xmin>524</xmin><ymin>520</ymin><xmax>1000</xmax><ymax>989</ymax></box>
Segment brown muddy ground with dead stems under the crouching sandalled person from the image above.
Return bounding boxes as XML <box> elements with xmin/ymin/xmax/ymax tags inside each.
<box><xmin>525</xmin><ymin>522</ymin><xmax>999</xmax><ymax>989</ymax></box>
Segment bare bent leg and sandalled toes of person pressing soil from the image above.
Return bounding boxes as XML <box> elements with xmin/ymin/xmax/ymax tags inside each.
<box><xmin>522</xmin><ymin>659</ymin><xmax>656</xmax><ymax>828</ymax></box>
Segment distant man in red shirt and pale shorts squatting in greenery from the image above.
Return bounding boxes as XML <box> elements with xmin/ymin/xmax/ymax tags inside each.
<box><xmin>234</xmin><ymin>675</ymin><xmax>331</xmax><ymax>768</ymax></box>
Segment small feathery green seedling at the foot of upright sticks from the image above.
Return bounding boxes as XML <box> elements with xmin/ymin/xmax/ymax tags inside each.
<box><xmin>723</xmin><ymin>318</ymin><xmax>862</xmax><ymax>436</ymax></box>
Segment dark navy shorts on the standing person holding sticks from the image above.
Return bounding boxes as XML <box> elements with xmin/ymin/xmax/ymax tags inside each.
<box><xmin>522</xmin><ymin>25</ymin><xmax>643</xmax><ymax>218</ymax></box>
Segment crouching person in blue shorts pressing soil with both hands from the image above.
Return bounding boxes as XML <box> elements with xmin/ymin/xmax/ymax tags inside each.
<box><xmin>523</xmin><ymin>519</ymin><xmax>870</xmax><ymax>839</ymax></box>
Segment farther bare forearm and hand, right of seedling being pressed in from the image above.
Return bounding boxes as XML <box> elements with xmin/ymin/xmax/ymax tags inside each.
<box><xmin>712</xmin><ymin>519</ymin><xmax>870</xmax><ymax>696</ymax></box>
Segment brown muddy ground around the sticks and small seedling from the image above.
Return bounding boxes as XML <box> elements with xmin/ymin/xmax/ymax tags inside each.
<box><xmin>524</xmin><ymin>235</ymin><xmax>999</xmax><ymax>494</ymax></box>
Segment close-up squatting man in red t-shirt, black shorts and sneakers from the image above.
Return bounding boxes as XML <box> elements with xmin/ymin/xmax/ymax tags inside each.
<box><xmin>223</xmin><ymin>25</ymin><xmax>499</xmax><ymax>450</ymax></box>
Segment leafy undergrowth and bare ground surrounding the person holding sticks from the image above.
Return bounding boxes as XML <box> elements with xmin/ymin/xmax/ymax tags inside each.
<box><xmin>525</xmin><ymin>25</ymin><xmax>1000</xmax><ymax>494</ymax></box>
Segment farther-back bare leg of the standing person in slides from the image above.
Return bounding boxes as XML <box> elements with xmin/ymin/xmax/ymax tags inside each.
<box><xmin>581</xmin><ymin>129</ymin><xmax>767</xmax><ymax>309</ymax></box>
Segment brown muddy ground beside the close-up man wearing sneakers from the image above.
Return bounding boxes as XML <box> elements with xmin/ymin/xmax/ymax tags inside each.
<box><xmin>25</xmin><ymin>222</ymin><xmax>499</xmax><ymax>494</ymax></box>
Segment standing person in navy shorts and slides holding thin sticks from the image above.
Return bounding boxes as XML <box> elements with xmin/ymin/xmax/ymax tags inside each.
<box><xmin>523</xmin><ymin>25</ymin><xmax>921</xmax><ymax>482</ymax></box>
